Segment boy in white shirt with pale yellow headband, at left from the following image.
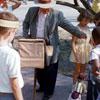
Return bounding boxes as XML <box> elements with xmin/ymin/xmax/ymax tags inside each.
<box><xmin>0</xmin><ymin>12</ymin><xmax>24</xmax><ymax>100</ymax></box>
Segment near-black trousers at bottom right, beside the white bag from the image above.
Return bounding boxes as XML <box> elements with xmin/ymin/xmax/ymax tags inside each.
<box><xmin>86</xmin><ymin>80</ymin><xmax>98</xmax><ymax>100</ymax></box>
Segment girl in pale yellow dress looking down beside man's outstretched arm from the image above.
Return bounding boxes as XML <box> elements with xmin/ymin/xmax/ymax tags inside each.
<box><xmin>70</xmin><ymin>11</ymin><xmax>92</xmax><ymax>84</ymax></box>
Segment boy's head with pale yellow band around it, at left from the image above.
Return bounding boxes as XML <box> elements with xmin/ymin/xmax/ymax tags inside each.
<box><xmin>0</xmin><ymin>12</ymin><xmax>19</xmax><ymax>43</ymax></box>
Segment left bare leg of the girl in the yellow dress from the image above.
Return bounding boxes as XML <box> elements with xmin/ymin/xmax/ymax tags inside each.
<box><xmin>73</xmin><ymin>63</ymin><xmax>81</xmax><ymax>85</ymax></box>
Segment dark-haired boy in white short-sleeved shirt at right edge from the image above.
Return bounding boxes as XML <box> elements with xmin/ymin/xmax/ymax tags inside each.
<box><xmin>88</xmin><ymin>27</ymin><xmax>100</xmax><ymax>100</ymax></box>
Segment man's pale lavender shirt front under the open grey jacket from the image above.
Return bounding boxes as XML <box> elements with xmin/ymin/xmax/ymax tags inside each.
<box><xmin>36</xmin><ymin>11</ymin><xmax>47</xmax><ymax>38</ymax></box>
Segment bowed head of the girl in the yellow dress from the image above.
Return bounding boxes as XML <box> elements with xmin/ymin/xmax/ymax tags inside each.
<box><xmin>77</xmin><ymin>10</ymin><xmax>92</xmax><ymax>27</ymax></box>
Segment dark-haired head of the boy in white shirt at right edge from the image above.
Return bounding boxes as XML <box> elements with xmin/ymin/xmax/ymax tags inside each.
<box><xmin>92</xmin><ymin>27</ymin><xmax>100</xmax><ymax>45</ymax></box>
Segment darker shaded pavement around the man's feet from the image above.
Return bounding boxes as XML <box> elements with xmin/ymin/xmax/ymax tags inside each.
<box><xmin>23</xmin><ymin>84</ymin><xmax>71</xmax><ymax>100</ymax></box>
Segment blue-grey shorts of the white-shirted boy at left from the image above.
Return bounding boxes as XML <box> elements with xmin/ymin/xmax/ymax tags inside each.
<box><xmin>0</xmin><ymin>93</ymin><xmax>16</xmax><ymax>100</ymax></box>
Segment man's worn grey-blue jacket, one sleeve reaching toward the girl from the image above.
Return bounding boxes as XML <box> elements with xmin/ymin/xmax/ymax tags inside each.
<box><xmin>23</xmin><ymin>7</ymin><xmax>82</xmax><ymax>63</ymax></box>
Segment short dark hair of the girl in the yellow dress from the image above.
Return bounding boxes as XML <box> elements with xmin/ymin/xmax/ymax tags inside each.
<box><xmin>77</xmin><ymin>10</ymin><xmax>93</xmax><ymax>22</ymax></box>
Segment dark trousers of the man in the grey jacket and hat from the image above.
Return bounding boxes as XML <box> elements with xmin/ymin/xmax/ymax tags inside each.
<box><xmin>37</xmin><ymin>62</ymin><xmax>58</xmax><ymax>95</ymax></box>
